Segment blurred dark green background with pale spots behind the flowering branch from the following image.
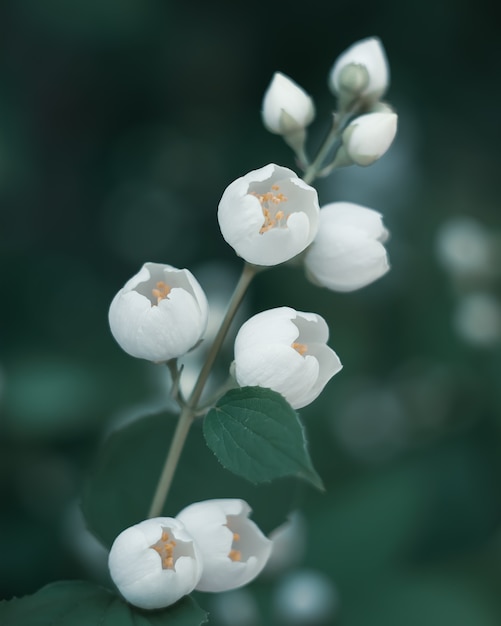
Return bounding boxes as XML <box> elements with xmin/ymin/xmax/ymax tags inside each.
<box><xmin>0</xmin><ymin>0</ymin><xmax>501</xmax><ymax>626</ymax></box>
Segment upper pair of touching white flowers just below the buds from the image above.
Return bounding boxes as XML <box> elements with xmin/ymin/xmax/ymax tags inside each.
<box><xmin>218</xmin><ymin>165</ymin><xmax>389</xmax><ymax>291</ymax></box>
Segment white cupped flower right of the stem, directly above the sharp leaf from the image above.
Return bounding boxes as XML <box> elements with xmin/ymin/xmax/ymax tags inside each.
<box><xmin>234</xmin><ymin>307</ymin><xmax>342</xmax><ymax>409</ymax></box>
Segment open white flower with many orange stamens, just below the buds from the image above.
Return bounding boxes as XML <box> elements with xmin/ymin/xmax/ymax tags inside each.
<box><xmin>218</xmin><ymin>163</ymin><xmax>319</xmax><ymax>265</ymax></box>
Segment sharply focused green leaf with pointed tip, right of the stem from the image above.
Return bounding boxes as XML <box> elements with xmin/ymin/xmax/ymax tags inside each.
<box><xmin>204</xmin><ymin>387</ymin><xmax>323</xmax><ymax>490</ymax></box>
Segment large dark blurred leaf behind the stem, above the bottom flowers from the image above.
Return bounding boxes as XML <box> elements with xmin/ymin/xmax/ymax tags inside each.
<box><xmin>82</xmin><ymin>413</ymin><xmax>302</xmax><ymax>547</ymax></box>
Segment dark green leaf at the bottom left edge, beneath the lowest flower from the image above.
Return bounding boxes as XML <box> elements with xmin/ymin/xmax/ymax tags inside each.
<box><xmin>0</xmin><ymin>581</ymin><xmax>207</xmax><ymax>626</ymax></box>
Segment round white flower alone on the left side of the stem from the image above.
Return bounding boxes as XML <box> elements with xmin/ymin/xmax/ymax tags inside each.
<box><xmin>109</xmin><ymin>263</ymin><xmax>209</xmax><ymax>363</ymax></box>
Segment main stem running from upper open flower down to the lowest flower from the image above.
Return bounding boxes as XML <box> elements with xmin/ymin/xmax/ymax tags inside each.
<box><xmin>148</xmin><ymin>263</ymin><xmax>258</xmax><ymax>518</ymax></box>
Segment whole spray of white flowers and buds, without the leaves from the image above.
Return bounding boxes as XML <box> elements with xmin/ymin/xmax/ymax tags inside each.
<box><xmin>109</xmin><ymin>38</ymin><xmax>397</xmax><ymax>609</ymax></box>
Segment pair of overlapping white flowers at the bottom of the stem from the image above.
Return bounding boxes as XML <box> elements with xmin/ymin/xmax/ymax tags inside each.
<box><xmin>109</xmin><ymin>499</ymin><xmax>272</xmax><ymax>609</ymax></box>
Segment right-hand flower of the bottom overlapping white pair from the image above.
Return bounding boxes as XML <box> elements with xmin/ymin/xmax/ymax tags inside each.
<box><xmin>177</xmin><ymin>499</ymin><xmax>272</xmax><ymax>591</ymax></box>
